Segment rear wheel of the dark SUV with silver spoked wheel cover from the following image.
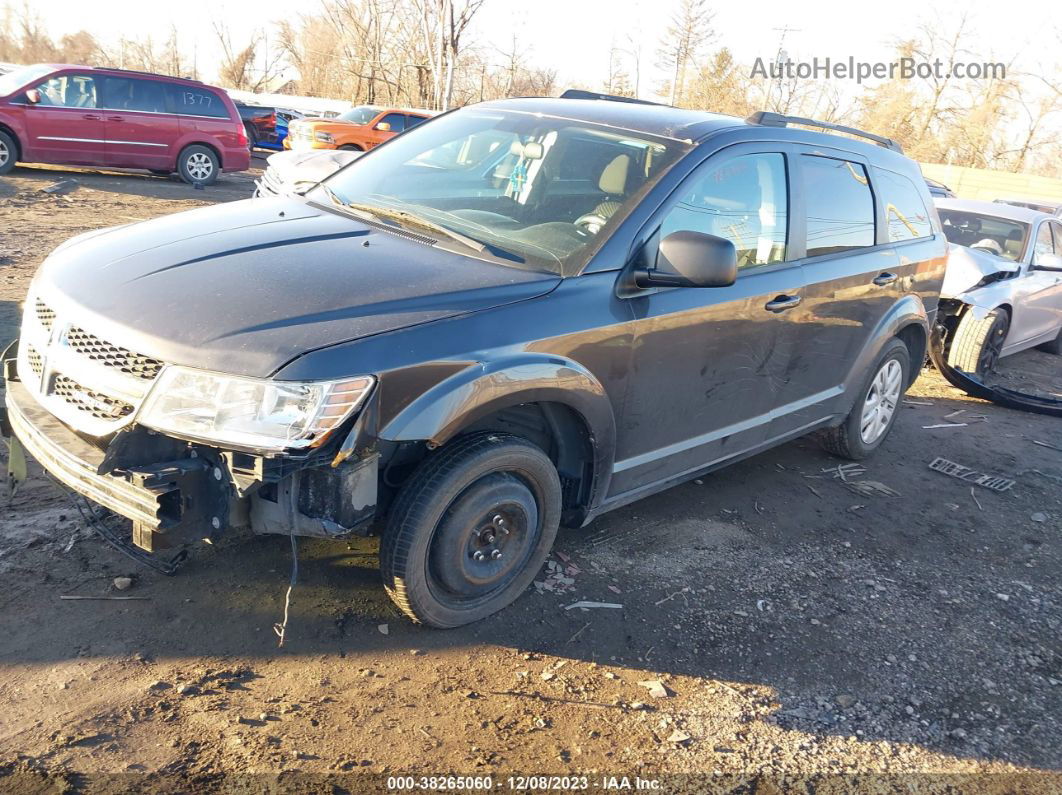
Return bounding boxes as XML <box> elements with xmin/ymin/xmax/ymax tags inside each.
<box><xmin>819</xmin><ymin>338</ymin><xmax>911</xmax><ymax>461</ymax></box>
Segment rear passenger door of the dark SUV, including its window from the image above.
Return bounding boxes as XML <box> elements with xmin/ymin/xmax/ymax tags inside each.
<box><xmin>770</xmin><ymin>146</ymin><xmax>904</xmax><ymax>436</ymax></box>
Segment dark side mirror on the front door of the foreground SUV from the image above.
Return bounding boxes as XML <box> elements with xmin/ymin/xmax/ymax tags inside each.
<box><xmin>634</xmin><ymin>230</ymin><xmax>737</xmax><ymax>287</ymax></box>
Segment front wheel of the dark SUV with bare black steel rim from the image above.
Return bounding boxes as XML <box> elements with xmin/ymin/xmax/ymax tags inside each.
<box><xmin>380</xmin><ymin>433</ymin><xmax>561</xmax><ymax>628</ymax></box>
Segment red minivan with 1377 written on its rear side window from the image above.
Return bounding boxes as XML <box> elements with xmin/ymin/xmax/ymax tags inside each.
<box><xmin>0</xmin><ymin>64</ymin><xmax>251</xmax><ymax>185</ymax></box>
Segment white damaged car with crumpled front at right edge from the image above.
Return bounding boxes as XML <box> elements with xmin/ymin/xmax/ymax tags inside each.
<box><xmin>936</xmin><ymin>198</ymin><xmax>1062</xmax><ymax>379</ymax></box>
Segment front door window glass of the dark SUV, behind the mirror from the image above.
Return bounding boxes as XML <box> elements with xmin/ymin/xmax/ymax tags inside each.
<box><xmin>661</xmin><ymin>153</ymin><xmax>789</xmax><ymax>267</ymax></box>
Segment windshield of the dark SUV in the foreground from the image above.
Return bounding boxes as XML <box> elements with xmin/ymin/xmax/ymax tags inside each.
<box><xmin>325</xmin><ymin>108</ymin><xmax>691</xmax><ymax>275</ymax></box>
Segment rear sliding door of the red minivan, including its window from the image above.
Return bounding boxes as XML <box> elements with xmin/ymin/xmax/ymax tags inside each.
<box><xmin>102</xmin><ymin>75</ymin><xmax>181</xmax><ymax>169</ymax></box>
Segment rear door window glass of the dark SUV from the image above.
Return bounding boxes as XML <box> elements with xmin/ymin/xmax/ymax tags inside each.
<box><xmin>802</xmin><ymin>155</ymin><xmax>874</xmax><ymax>257</ymax></box>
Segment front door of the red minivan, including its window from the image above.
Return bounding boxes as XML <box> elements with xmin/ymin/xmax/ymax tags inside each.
<box><xmin>24</xmin><ymin>72</ymin><xmax>106</xmax><ymax>166</ymax></box>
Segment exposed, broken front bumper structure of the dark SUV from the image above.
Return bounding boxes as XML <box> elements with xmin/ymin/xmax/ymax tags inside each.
<box><xmin>0</xmin><ymin>348</ymin><xmax>379</xmax><ymax>552</ymax></box>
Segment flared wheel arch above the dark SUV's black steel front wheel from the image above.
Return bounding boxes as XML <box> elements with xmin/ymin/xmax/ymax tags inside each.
<box><xmin>378</xmin><ymin>353</ymin><xmax>616</xmax><ymax>505</ymax></box>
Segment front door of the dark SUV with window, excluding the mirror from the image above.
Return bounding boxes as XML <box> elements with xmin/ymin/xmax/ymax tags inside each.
<box><xmin>612</xmin><ymin>144</ymin><xmax>803</xmax><ymax>495</ymax></box>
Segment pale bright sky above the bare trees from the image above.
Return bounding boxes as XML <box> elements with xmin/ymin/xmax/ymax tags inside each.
<box><xmin>18</xmin><ymin>0</ymin><xmax>1062</xmax><ymax>99</ymax></box>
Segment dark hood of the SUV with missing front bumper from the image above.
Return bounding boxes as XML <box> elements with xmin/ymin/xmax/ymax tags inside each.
<box><xmin>33</xmin><ymin>197</ymin><xmax>560</xmax><ymax>377</ymax></box>
